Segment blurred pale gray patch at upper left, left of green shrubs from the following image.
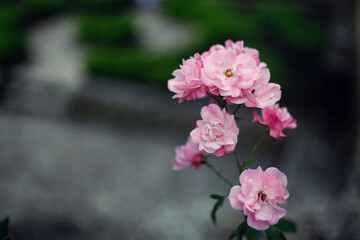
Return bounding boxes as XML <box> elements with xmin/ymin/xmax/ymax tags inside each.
<box><xmin>14</xmin><ymin>15</ymin><xmax>86</xmax><ymax>91</ymax></box>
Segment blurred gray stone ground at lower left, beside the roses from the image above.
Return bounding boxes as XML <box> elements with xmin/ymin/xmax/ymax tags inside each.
<box><xmin>0</xmin><ymin>111</ymin><xmax>228</xmax><ymax>239</ymax></box>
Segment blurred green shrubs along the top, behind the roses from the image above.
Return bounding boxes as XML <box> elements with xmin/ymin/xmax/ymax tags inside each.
<box><xmin>0</xmin><ymin>0</ymin><xmax>324</xmax><ymax>90</ymax></box>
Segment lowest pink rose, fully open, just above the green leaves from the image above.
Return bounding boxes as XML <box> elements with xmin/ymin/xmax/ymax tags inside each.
<box><xmin>229</xmin><ymin>167</ymin><xmax>289</xmax><ymax>230</ymax></box>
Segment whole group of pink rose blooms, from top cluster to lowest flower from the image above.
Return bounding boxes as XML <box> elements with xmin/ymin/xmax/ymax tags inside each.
<box><xmin>168</xmin><ymin>40</ymin><xmax>297</xmax><ymax>230</ymax></box>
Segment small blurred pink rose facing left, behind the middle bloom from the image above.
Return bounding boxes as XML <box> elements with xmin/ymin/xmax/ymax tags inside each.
<box><xmin>172</xmin><ymin>137</ymin><xmax>203</xmax><ymax>170</ymax></box>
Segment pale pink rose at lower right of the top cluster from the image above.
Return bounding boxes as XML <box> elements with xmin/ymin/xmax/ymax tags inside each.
<box><xmin>224</xmin><ymin>63</ymin><xmax>281</xmax><ymax>108</ymax></box>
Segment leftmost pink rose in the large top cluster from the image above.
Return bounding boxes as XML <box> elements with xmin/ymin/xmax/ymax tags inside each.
<box><xmin>168</xmin><ymin>53</ymin><xmax>207</xmax><ymax>103</ymax></box>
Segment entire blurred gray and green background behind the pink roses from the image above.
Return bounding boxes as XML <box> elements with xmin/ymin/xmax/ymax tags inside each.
<box><xmin>0</xmin><ymin>0</ymin><xmax>360</xmax><ymax>240</ymax></box>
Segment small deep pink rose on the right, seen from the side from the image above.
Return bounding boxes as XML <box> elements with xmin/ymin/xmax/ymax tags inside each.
<box><xmin>252</xmin><ymin>104</ymin><xmax>297</xmax><ymax>140</ymax></box>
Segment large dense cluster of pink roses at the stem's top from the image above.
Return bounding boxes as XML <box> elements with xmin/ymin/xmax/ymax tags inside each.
<box><xmin>168</xmin><ymin>40</ymin><xmax>281</xmax><ymax>108</ymax></box>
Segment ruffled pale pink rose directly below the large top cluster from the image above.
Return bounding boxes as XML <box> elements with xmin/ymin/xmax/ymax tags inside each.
<box><xmin>190</xmin><ymin>103</ymin><xmax>239</xmax><ymax>157</ymax></box>
